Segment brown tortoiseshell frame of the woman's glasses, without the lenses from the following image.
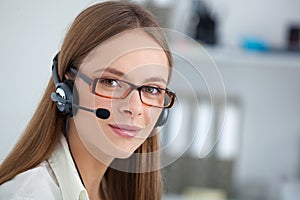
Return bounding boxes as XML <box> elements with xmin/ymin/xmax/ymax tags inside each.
<box><xmin>70</xmin><ymin>68</ymin><xmax>176</xmax><ymax>108</ymax></box>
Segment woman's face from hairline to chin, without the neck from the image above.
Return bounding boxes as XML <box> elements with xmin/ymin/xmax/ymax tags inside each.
<box><xmin>74</xmin><ymin>30</ymin><xmax>169</xmax><ymax>161</ymax></box>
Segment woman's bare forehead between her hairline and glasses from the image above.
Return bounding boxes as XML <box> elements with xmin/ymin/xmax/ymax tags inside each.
<box><xmin>80</xmin><ymin>29</ymin><xmax>169</xmax><ymax>80</ymax></box>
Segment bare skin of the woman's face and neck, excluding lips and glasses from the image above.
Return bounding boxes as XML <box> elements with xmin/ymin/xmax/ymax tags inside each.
<box><xmin>69</xmin><ymin>31</ymin><xmax>169</xmax><ymax>200</ymax></box>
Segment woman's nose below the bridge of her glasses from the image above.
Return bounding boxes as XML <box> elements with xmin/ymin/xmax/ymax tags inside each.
<box><xmin>119</xmin><ymin>90</ymin><xmax>143</xmax><ymax>117</ymax></box>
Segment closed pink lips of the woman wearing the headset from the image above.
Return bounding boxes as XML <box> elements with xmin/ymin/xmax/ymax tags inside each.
<box><xmin>109</xmin><ymin>124</ymin><xmax>141</xmax><ymax>138</ymax></box>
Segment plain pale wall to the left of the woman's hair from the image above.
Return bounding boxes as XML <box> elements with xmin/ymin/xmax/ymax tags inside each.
<box><xmin>0</xmin><ymin>0</ymin><xmax>104</xmax><ymax>161</ymax></box>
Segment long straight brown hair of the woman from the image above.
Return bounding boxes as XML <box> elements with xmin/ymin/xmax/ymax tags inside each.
<box><xmin>0</xmin><ymin>1</ymin><xmax>172</xmax><ymax>200</ymax></box>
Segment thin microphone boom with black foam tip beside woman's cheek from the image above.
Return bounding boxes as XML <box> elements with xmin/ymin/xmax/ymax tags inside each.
<box><xmin>51</xmin><ymin>92</ymin><xmax>110</xmax><ymax>119</ymax></box>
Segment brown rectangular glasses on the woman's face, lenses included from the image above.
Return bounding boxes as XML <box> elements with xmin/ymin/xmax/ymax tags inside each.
<box><xmin>70</xmin><ymin>68</ymin><xmax>176</xmax><ymax>108</ymax></box>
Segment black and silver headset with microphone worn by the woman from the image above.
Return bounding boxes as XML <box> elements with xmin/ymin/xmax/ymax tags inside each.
<box><xmin>51</xmin><ymin>53</ymin><xmax>169</xmax><ymax>127</ymax></box>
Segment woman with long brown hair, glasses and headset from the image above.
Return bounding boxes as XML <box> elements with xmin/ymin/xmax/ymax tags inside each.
<box><xmin>0</xmin><ymin>1</ymin><xmax>175</xmax><ymax>200</ymax></box>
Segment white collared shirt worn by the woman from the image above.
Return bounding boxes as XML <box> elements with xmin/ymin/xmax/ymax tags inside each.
<box><xmin>0</xmin><ymin>137</ymin><xmax>89</xmax><ymax>200</ymax></box>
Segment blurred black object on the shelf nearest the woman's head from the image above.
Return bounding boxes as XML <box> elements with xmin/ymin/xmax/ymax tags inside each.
<box><xmin>190</xmin><ymin>0</ymin><xmax>217</xmax><ymax>45</ymax></box>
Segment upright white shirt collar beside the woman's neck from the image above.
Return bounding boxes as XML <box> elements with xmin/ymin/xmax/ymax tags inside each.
<box><xmin>48</xmin><ymin>136</ymin><xmax>89</xmax><ymax>200</ymax></box>
